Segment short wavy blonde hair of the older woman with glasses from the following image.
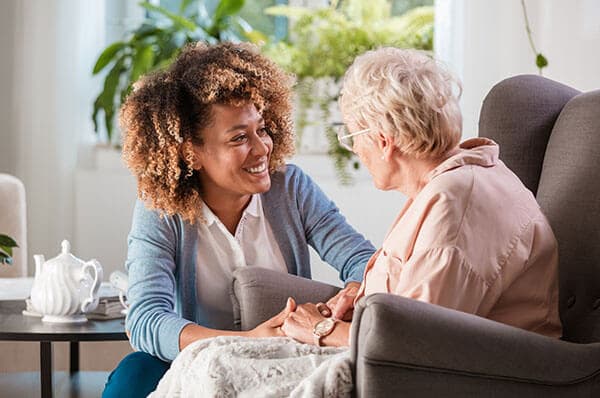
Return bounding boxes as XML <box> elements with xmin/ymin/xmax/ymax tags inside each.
<box><xmin>339</xmin><ymin>47</ymin><xmax>462</xmax><ymax>158</ymax></box>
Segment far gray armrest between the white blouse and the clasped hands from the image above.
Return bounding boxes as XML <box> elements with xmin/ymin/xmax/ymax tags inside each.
<box><xmin>231</xmin><ymin>267</ymin><xmax>340</xmax><ymax>330</ymax></box>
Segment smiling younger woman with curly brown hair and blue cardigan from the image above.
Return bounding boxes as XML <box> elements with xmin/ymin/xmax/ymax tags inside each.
<box><xmin>103</xmin><ymin>43</ymin><xmax>375</xmax><ymax>397</ymax></box>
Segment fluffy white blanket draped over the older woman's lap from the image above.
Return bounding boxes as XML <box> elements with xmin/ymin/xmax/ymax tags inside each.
<box><xmin>149</xmin><ymin>337</ymin><xmax>352</xmax><ymax>398</ymax></box>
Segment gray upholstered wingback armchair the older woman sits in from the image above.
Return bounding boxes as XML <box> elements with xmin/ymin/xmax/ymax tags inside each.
<box><xmin>233</xmin><ymin>75</ymin><xmax>600</xmax><ymax>397</ymax></box>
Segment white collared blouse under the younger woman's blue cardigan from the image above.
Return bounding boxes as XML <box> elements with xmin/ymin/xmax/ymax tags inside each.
<box><xmin>196</xmin><ymin>194</ymin><xmax>287</xmax><ymax>329</ymax></box>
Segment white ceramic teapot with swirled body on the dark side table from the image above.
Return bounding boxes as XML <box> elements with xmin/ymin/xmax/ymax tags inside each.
<box><xmin>31</xmin><ymin>240</ymin><xmax>103</xmax><ymax>323</ymax></box>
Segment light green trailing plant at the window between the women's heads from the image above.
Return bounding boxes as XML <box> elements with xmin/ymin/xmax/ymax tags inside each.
<box><xmin>264</xmin><ymin>0</ymin><xmax>433</xmax><ymax>183</ymax></box>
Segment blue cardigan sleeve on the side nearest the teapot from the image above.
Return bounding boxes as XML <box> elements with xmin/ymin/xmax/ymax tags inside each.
<box><xmin>125</xmin><ymin>200</ymin><xmax>191</xmax><ymax>361</ymax></box>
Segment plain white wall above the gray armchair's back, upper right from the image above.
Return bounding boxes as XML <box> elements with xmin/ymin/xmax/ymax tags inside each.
<box><xmin>435</xmin><ymin>0</ymin><xmax>600</xmax><ymax>137</ymax></box>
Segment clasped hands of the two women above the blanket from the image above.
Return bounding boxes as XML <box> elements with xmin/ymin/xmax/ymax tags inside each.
<box><xmin>250</xmin><ymin>282</ymin><xmax>360</xmax><ymax>344</ymax></box>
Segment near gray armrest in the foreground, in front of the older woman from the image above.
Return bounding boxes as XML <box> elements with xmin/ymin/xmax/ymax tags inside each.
<box><xmin>351</xmin><ymin>294</ymin><xmax>600</xmax><ymax>397</ymax></box>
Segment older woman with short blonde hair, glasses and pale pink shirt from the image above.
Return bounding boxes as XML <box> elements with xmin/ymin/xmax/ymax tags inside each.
<box><xmin>282</xmin><ymin>48</ymin><xmax>561</xmax><ymax>346</ymax></box>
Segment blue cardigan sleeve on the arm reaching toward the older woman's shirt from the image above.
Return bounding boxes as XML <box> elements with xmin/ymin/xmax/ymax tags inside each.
<box><xmin>288</xmin><ymin>165</ymin><xmax>375</xmax><ymax>283</ymax></box>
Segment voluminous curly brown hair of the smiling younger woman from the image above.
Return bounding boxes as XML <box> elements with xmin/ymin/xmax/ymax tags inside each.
<box><xmin>120</xmin><ymin>43</ymin><xmax>294</xmax><ymax>223</ymax></box>
